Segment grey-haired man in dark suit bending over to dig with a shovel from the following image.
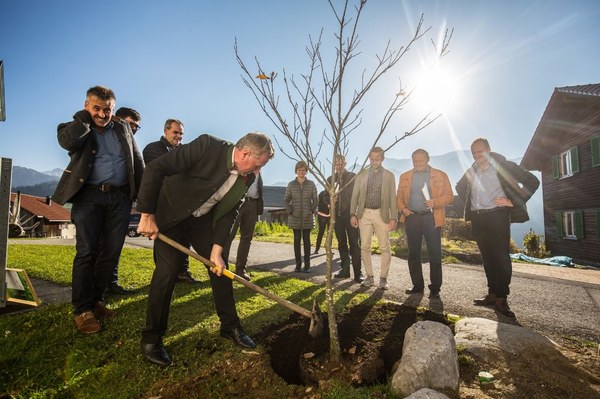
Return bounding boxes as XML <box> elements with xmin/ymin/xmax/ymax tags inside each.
<box><xmin>137</xmin><ymin>133</ymin><xmax>274</xmax><ymax>366</ymax></box>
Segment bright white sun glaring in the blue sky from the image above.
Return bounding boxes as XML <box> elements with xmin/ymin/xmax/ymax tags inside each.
<box><xmin>413</xmin><ymin>65</ymin><xmax>460</xmax><ymax>113</ymax></box>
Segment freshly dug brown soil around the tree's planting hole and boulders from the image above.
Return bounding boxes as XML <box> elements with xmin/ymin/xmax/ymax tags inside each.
<box><xmin>156</xmin><ymin>303</ymin><xmax>600</xmax><ymax>399</ymax></box>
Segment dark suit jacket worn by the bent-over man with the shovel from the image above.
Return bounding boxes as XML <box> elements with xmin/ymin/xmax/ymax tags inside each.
<box><xmin>136</xmin><ymin>134</ymin><xmax>254</xmax><ymax>246</ymax></box>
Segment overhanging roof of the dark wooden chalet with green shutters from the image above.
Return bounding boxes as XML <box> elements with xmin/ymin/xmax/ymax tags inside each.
<box><xmin>521</xmin><ymin>83</ymin><xmax>600</xmax><ymax>171</ymax></box>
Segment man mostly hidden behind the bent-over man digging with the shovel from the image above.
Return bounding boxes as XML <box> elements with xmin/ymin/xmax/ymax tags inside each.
<box><xmin>142</xmin><ymin>119</ymin><xmax>200</xmax><ymax>284</ymax></box>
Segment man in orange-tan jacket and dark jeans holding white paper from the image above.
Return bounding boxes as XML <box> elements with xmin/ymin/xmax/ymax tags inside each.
<box><xmin>397</xmin><ymin>149</ymin><xmax>454</xmax><ymax>299</ymax></box>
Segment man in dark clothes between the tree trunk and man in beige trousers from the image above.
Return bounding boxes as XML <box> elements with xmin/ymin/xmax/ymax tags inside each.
<box><xmin>329</xmin><ymin>155</ymin><xmax>364</xmax><ymax>283</ymax></box>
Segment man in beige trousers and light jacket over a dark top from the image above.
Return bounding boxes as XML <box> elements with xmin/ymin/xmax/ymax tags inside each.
<box><xmin>350</xmin><ymin>147</ymin><xmax>398</xmax><ymax>290</ymax></box>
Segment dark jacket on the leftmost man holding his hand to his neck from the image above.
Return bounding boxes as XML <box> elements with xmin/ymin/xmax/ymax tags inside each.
<box><xmin>52</xmin><ymin>114</ymin><xmax>144</xmax><ymax>205</ymax></box>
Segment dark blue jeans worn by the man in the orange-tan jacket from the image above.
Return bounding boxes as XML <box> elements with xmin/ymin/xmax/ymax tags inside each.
<box><xmin>405</xmin><ymin>213</ymin><xmax>442</xmax><ymax>292</ymax></box>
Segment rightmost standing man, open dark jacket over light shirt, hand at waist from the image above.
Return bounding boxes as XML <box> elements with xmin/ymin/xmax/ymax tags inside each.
<box><xmin>456</xmin><ymin>138</ymin><xmax>540</xmax><ymax>317</ymax></box>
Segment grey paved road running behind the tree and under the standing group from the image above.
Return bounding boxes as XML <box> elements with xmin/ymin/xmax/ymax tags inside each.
<box><xmin>9</xmin><ymin>237</ymin><xmax>600</xmax><ymax>342</ymax></box>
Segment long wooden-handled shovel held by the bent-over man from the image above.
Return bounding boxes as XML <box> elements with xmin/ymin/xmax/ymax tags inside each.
<box><xmin>158</xmin><ymin>233</ymin><xmax>323</xmax><ymax>338</ymax></box>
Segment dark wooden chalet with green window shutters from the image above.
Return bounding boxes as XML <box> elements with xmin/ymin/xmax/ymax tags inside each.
<box><xmin>521</xmin><ymin>84</ymin><xmax>600</xmax><ymax>265</ymax></box>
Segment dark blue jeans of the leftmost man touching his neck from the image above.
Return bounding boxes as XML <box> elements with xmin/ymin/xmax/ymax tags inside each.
<box><xmin>71</xmin><ymin>186</ymin><xmax>131</xmax><ymax>314</ymax></box>
